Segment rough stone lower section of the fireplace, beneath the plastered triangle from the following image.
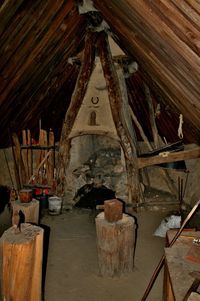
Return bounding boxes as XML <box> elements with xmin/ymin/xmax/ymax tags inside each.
<box><xmin>65</xmin><ymin>134</ymin><xmax>127</xmax><ymax>205</ymax></box>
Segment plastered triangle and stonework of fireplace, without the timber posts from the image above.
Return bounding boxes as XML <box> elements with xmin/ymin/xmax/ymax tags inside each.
<box><xmin>62</xmin><ymin>57</ymin><xmax>127</xmax><ymax>204</ymax></box>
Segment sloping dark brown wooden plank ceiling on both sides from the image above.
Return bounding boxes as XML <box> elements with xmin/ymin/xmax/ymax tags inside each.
<box><xmin>0</xmin><ymin>0</ymin><xmax>200</xmax><ymax>147</ymax></box>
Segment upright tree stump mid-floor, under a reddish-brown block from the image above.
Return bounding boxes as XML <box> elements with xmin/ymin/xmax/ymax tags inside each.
<box><xmin>95</xmin><ymin>212</ymin><xmax>135</xmax><ymax>277</ymax></box>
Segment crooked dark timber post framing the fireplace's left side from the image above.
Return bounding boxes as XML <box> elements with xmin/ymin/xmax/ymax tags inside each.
<box><xmin>56</xmin><ymin>32</ymin><xmax>97</xmax><ymax>196</ymax></box>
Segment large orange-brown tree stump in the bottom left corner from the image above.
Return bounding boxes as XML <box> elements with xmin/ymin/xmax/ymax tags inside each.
<box><xmin>0</xmin><ymin>224</ymin><xmax>43</xmax><ymax>301</ymax></box>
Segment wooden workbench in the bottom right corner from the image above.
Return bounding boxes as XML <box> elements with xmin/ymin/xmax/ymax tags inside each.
<box><xmin>163</xmin><ymin>230</ymin><xmax>200</xmax><ymax>301</ymax></box>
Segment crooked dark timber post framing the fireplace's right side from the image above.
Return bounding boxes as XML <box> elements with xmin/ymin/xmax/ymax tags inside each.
<box><xmin>97</xmin><ymin>32</ymin><xmax>140</xmax><ymax>203</ymax></box>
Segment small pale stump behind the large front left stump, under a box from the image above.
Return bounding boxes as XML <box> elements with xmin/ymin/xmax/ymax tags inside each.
<box><xmin>12</xmin><ymin>199</ymin><xmax>40</xmax><ymax>225</ymax></box>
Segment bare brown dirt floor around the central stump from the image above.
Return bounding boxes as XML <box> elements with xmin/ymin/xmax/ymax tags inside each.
<box><xmin>42</xmin><ymin>209</ymin><xmax>170</xmax><ymax>301</ymax></box>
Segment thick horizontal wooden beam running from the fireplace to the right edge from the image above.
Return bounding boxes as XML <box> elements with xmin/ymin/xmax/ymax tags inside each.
<box><xmin>138</xmin><ymin>147</ymin><xmax>200</xmax><ymax>168</ymax></box>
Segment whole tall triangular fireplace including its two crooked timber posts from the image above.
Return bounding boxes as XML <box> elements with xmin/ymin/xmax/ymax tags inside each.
<box><xmin>57</xmin><ymin>32</ymin><xmax>139</xmax><ymax>206</ymax></box>
